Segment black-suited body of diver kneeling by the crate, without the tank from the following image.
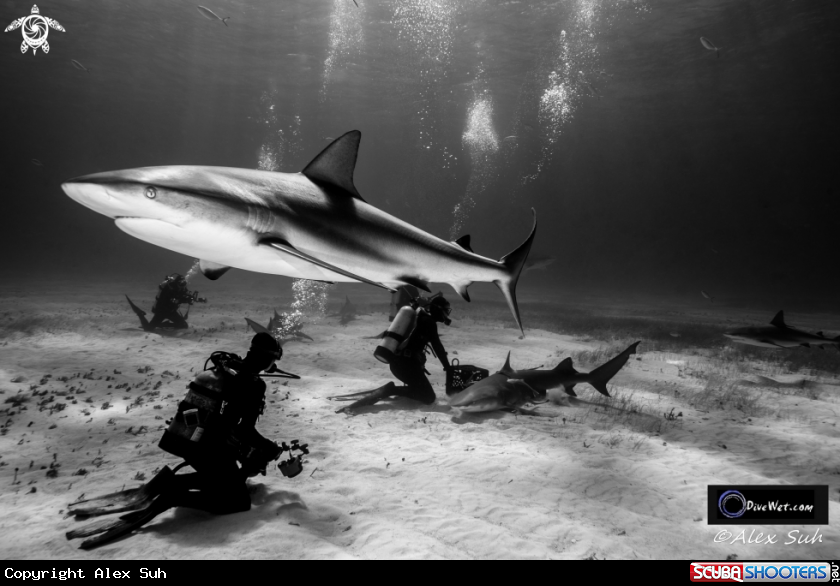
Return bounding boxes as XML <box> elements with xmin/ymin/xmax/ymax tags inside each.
<box><xmin>337</xmin><ymin>293</ymin><xmax>452</xmax><ymax>413</ymax></box>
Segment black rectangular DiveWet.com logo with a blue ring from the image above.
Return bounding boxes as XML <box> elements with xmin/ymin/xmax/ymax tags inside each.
<box><xmin>708</xmin><ymin>484</ymin><xmax>828</xmax><ymax>525</ymax></box>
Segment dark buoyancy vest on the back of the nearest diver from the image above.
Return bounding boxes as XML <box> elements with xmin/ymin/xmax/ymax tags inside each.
<box><xmin>158</xmin><ymin>368</ymin><xmax>242</xmax><ymax>459</ymax></box>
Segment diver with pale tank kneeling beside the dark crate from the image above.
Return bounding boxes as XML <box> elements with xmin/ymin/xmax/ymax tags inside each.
<box><xmin>330</xmin><ymin>293</ymin><xmax>452</xmax><ymax>413</ymax></box>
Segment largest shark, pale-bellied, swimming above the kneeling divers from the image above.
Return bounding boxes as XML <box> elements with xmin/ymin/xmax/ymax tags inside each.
<box><xmin>61</xmin><ymin>130</ymin><xmax>537</xmax><ymax>331</ymax></box>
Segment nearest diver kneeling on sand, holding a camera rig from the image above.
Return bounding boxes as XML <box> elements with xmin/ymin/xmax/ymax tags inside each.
<box><xmin>67</xmin><ymin>333</ymin><xmax>308</xmax><ymax>549</ymax></box>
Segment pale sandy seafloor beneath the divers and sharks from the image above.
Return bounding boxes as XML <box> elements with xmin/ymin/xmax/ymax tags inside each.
<box><xmin>0</xmin><ymin>275</ymin><xmax>840</xmax><ymax>560</ymax></box>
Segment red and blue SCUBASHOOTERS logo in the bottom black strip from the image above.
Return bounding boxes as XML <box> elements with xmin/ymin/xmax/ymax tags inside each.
<box><xmin>691</xmin><ymin>562</ymin><xmax>840</xmax><ymax>583</ymax></box>
